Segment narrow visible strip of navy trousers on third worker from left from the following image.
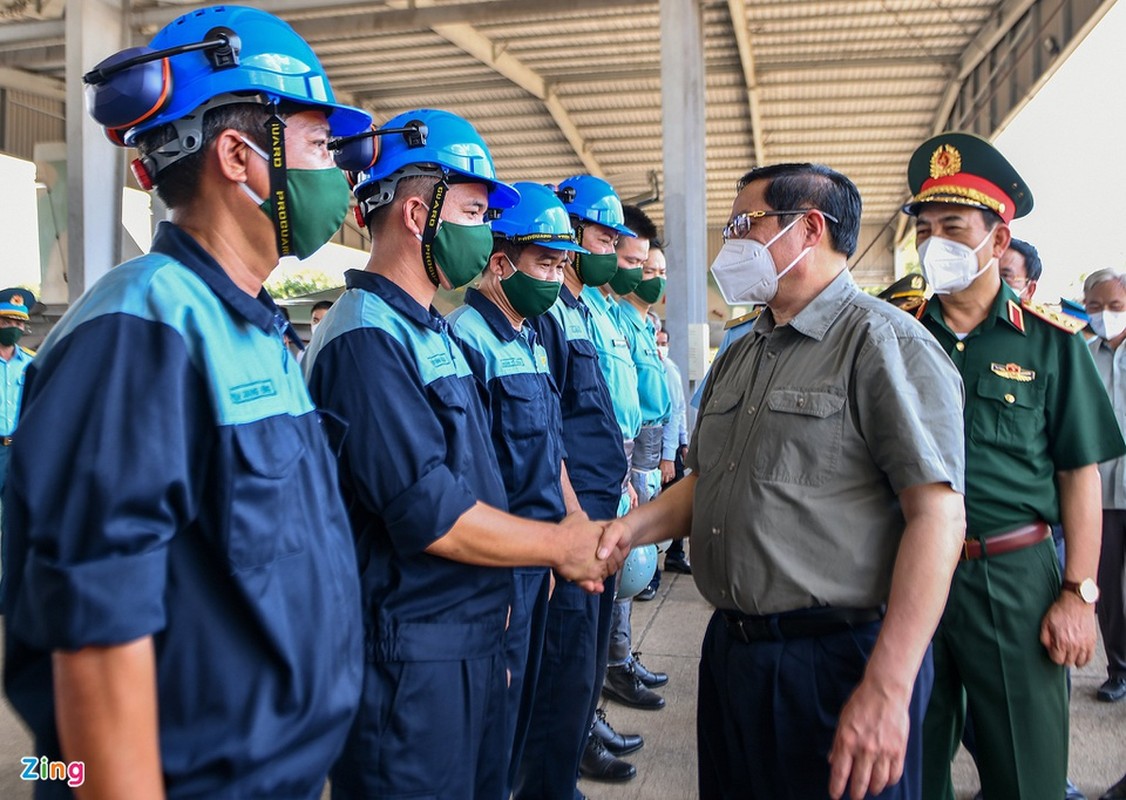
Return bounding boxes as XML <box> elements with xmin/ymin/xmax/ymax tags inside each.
<box><xmin>504</xmin><ymin>568</ymin><xmax>551</xmax><ymax>797</ymax></box>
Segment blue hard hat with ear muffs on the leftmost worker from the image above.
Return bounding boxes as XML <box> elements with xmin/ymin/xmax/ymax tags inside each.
<box><xmin>84</xmin><ymin>6</ymin><xmax>372</xmax><ymax>146</ymax></box>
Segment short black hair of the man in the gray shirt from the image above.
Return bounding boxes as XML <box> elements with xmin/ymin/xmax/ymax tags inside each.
<box><xmin>736</xmin><ymin>163</ymin><xmax>861</xmax><ymax>258</ymax></box>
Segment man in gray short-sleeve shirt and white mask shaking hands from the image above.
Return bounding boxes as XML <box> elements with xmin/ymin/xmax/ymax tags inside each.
<box><xmin>604</xmin><ymin>165</ymin><xmax>965</xmax><ymax>800</ymax></box>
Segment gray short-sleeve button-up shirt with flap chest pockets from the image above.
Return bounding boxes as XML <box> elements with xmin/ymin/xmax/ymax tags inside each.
<box><xmin>686</xmin><ymin>270</ymin><xmax>965</xmax><ymax>614</ymax></box>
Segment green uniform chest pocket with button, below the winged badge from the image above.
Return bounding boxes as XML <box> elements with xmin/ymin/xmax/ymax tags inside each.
<box><xmin>969</xmin><ymin>373</ymin><xmax>1045</xmax><ymax>453</ymax></box>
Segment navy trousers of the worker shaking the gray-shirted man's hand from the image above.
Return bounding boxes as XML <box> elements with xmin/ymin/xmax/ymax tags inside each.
<box><xmin>331</xmin><ymin>648</ymin><xmax>509</xmax><ymax>800</ymax></box>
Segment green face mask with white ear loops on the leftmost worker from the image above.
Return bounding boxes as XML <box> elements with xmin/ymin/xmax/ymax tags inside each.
<box><xmin>239</xmin><ymin>139</ymin><xmax>351</xmax><ymax>259</ymax></box>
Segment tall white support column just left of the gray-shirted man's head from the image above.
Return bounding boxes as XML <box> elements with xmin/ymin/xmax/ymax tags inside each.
<box><xmin>660</xmin><ymin>0</ymin><xmax>707</xmax><ymax>410</ymax></box>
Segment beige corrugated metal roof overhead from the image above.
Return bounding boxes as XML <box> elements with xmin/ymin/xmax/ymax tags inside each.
<box><xmin>0</xmin><ymin>0</ymin><xmax>1098</xmax><ymax>283</ymax></box>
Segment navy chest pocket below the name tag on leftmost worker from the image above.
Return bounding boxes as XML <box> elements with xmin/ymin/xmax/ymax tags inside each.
<box><xmin>226</xmin><ymin>420</ymin><xmax>312</xmax><ymax>570</ymax></box>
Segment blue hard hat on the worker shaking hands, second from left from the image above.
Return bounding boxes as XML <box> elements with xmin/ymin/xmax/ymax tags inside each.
<box><xmin>352</xmin><ymin>108</ymin><xmax>520</xmax><ymax>215</ymax></box>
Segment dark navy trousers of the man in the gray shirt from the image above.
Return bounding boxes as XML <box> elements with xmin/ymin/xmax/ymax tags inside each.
<box><xmin>696</xmin><ymin>612</ymin><xmax>933</xmax><ymax>800</ymax></box>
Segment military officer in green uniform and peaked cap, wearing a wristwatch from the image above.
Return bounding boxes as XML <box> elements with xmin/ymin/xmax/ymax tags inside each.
<box><xmin>904</xmin><ymin>133</ymin><xmax>1126</xmax><ymax>800</ymax></box>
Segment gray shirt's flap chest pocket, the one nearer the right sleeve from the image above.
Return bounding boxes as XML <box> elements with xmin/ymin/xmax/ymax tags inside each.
<box><xmin>751</xmin><ymin>389</ymin><xmax>845</xmax><ymax>487</ymax></box>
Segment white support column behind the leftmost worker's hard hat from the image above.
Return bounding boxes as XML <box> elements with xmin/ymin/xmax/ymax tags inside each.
<box><xmin>66</xmin><ymin>0</ymin><xmax>127</xmax><ymax>303</ymax></box>
